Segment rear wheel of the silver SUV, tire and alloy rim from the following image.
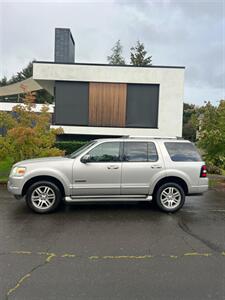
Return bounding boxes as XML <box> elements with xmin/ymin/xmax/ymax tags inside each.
<box><xmin>155</xmin><ymin>182</ymin><xmax>185</xmax><ymax>213</ymax></box>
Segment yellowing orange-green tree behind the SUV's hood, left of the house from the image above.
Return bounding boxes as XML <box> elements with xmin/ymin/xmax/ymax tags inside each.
<box><xmin>0</xmin><ymin>92</ymin><xmax>64</xmax><ymax>163</ymax></box>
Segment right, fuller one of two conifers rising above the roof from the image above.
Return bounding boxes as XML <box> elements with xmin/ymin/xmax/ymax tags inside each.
<box><xmin>130</xmin><ymin>41</ymin><xmax>152</xmax><ymax>66</ymax></box>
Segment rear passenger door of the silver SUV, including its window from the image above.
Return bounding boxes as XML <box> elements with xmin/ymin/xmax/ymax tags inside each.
<box><xmin>121</xmin><ymin>141</ymin><xmax>164</xmax><ymax>195</ymax></box>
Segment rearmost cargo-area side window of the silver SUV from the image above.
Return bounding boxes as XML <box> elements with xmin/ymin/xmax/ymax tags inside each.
<box><xmin>165</xmin><ymin>142</ymin><xmax>202</xmax><ymax>161</ymax></box>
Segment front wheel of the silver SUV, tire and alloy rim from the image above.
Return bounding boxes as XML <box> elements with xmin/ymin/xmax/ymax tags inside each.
<box><xmin>26</xmin><ymin>181</ymin><xmax>62</xmax><ymax>214</ymax></box>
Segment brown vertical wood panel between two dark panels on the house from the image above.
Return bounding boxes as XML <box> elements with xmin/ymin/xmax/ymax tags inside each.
<box><xmin>89</xmin><ymin>82</ymin><xmax>127</xmax><ymax>127</ymax></box>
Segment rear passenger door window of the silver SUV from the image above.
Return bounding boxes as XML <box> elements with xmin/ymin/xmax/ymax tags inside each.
<box><xmin>124</xmin><ymin>142</ymin><xmax>158</xmax><ymax>162</ymax></box>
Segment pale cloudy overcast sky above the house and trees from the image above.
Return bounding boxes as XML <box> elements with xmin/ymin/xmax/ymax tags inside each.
<box><xmin>0</xmin><ymin>0</ymin><xmax>225</xmax><ymax>104</ymax></box>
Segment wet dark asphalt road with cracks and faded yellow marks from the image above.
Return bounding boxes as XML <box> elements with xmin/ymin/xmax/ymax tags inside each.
<box><xmin>0</xmin><ymin>190</ymin><xmax>225</xmax><ymax>300</ymax></box>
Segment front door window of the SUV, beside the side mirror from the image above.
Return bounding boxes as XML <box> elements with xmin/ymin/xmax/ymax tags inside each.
<box><xmin>88</xmin><ymin>142</ymin><xmax>120</xmax><ymax>162</ymax></box>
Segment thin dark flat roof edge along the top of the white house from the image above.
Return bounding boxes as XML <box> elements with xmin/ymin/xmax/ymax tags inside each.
<box><xmin>34</xmin><ymin>61</ymin><xmax>185</xmax><ymax>69</ymax></box>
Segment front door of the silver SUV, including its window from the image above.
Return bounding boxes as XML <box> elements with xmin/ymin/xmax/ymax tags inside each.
<box><xmin>73</xmin><ymin>142</ymin><xmax>121</xmax><ymax>196</ymax></box>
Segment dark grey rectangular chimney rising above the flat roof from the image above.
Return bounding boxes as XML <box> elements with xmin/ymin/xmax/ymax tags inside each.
<box><xmin>55</xmin><ymin>28</ymin><xmax>75</xmax><ymax>63</ymax></box>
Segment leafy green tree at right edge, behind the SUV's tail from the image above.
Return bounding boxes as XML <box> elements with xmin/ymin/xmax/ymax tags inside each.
<box><xmin>198</xmin><ymin>100</ymin><xmax>225</xmax><ymax>169</ymax></box>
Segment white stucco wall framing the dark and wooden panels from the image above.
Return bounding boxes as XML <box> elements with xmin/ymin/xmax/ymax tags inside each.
<box><xmin>33</xmin><ymin>63</ymin><xmax>184</xmax><ymax>136</ymax></box>
